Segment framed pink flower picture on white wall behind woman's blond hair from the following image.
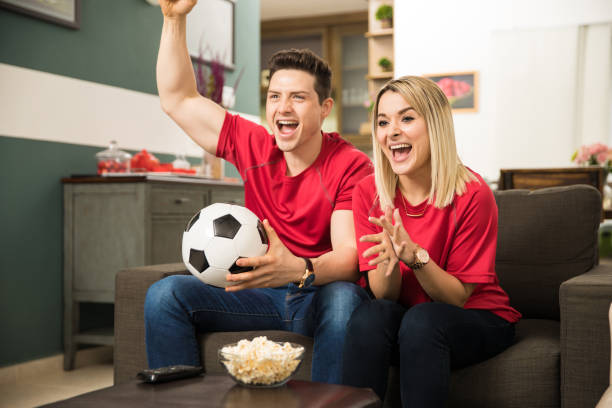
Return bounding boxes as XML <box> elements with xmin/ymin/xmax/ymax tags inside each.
<box><xmin>424</xmin><ymin>71</ymin><xmax>478</xmax><ymax>112</ymax></box>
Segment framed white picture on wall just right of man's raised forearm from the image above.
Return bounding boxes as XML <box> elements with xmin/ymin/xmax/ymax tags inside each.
<box><xmin>187</xmin><ymin>0</ymin><xmax>235</xmax><ymax>70</ymax></box>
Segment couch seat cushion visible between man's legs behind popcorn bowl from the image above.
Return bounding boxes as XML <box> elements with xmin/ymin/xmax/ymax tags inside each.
<box><xmin>199</xmin><ymin>330</ymin><xmax>313</xmax><ymax>380</ymax></box>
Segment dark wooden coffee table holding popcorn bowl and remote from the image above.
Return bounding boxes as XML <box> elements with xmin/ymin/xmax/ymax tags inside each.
<box><xmin>44</xmin><ymin>375</ymin><xmax>382</xmax><ymax>408</ymax></box>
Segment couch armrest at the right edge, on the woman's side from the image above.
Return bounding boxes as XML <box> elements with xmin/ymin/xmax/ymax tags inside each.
<box><xmin>559</xmin><ymin>265</ymin><xmax>612</xmax><ymax>408</ymax></box>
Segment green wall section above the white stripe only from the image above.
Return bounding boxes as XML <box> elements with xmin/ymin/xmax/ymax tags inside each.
<box><xmin>0</xmin><ymin>0</ymin><xmax>260</xmax><ymax>115</ymax></box>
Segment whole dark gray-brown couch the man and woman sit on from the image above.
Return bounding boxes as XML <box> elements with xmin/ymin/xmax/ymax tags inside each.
<box><xmin>115</xmin><ymin>185</ymin><xmax>612</xmax><ymax>408</ymax></box>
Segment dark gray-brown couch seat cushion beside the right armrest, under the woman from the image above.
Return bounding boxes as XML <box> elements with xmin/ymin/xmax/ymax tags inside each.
<box><xmin>449</xmin><ymin>319</ymin><xmax>560</xmax><ymax>408</ymax></box>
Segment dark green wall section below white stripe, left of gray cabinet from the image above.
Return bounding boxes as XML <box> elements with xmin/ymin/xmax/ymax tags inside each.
<box><xmin>0</xmin><ymin>137</ymin><xmax>112</xmax><ymax>365</ymax></box>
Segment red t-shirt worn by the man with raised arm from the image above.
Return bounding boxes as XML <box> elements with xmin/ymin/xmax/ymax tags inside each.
<box><xmin>217</xmin><ymin>113</ymin><xmax>372</xmax><ymax>258</ymax></box>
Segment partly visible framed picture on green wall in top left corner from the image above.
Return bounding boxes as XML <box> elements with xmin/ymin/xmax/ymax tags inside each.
<box><xmin>0</xmin><ymin>0</ymin><xmax>81</xmax><ymax>29</ymax></box>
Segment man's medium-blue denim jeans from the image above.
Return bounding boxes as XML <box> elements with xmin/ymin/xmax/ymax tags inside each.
<box><xmin>145</xmin><ymin>275</ymin><xmax>368</xmax><ymax>384</ymax></box>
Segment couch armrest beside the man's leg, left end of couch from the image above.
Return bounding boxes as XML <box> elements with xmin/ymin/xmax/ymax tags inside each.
<box><xmin>113</xmin><ymin>263</ymin><xmax>188</xmax><ymax>384</ymax></box>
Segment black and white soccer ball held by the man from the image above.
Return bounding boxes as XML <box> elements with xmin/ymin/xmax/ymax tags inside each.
<box><xmin>182</xmin><ymin>203</ymin><xmax>268</xmax><ymax>287</ymax></box>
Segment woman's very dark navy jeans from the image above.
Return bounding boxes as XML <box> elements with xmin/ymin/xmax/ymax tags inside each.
<box><xmin>343</xmin><ymin>300</ymin><xmax>514</xmax><ymax>408</ymax></box>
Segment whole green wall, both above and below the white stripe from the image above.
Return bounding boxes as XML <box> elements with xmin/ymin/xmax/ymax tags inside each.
<box><xmin>0</xmin><ymin>0</ymin><xmax>260</xmax><ymax>366</ymax></box>
